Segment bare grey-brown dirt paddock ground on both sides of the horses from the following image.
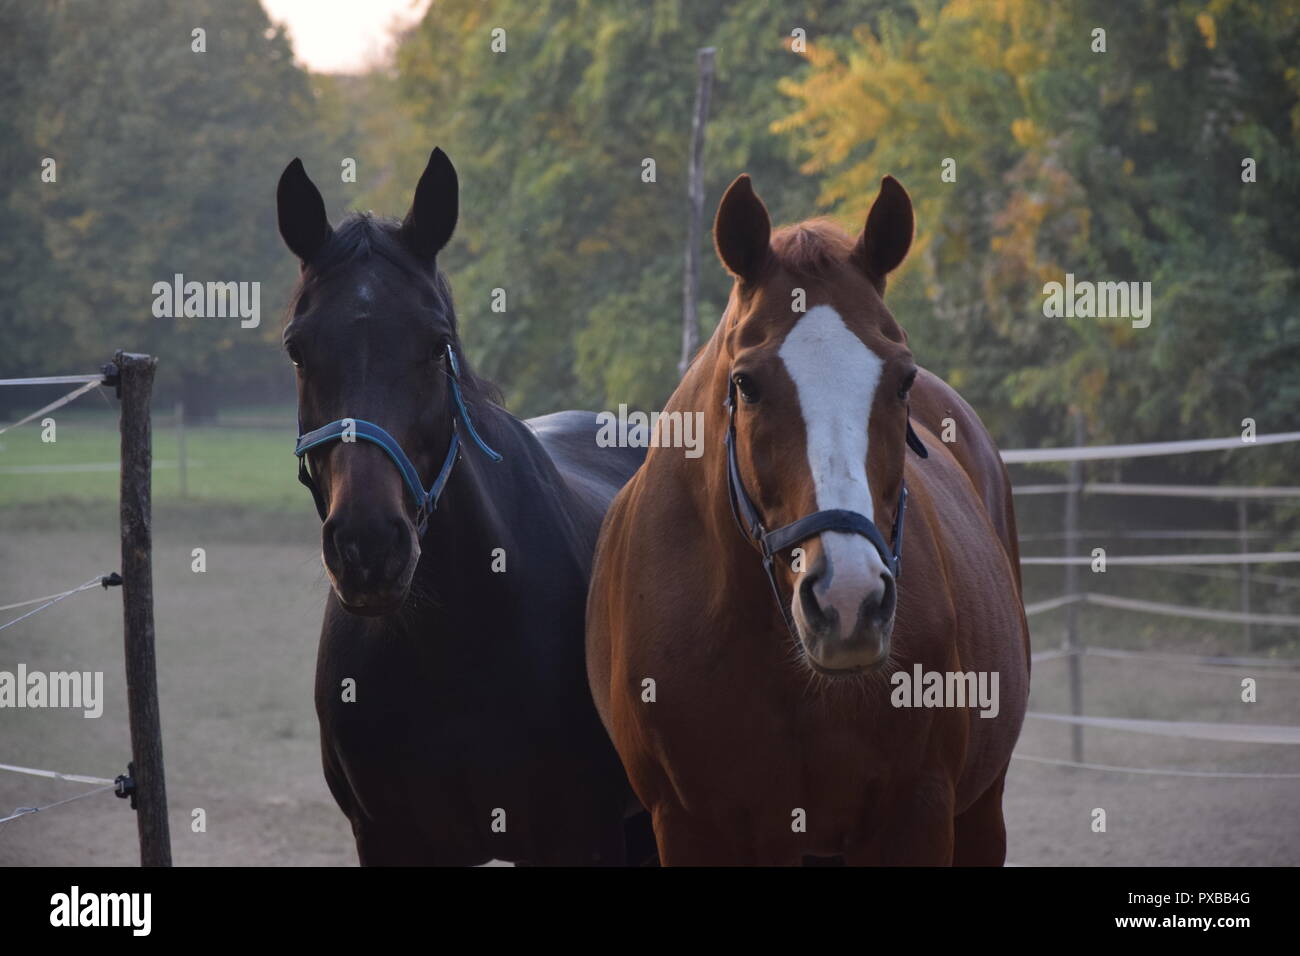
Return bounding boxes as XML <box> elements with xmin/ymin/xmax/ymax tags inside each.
<box><xmin>0</xmin><ymin>503</ymin><xmax>1300</xmax><ymax>866</ymax></box>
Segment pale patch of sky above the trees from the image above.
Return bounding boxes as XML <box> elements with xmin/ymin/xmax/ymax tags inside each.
<box><xmin>261</xmin><ymin>0</ymin><xmax>429</xmax><ymax>73</ymax></box>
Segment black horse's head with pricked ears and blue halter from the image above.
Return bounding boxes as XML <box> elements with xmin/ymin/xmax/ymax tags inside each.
<box><xmin>277</xmin><ymin>150</ymin><xmax>488</xmax><ymax>615</ymax></box>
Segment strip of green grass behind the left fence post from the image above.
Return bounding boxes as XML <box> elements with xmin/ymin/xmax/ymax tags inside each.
<box><xmin>0</xmin><ymin>407</ymin><xmax>299</xmax><ymax>510</ymax></box>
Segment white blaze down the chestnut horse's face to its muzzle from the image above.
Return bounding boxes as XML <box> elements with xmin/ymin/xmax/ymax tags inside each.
<box><xmin>780</xmin><ymin>306</ymin><xmax>887</xmax><ymax>636</ymax></box>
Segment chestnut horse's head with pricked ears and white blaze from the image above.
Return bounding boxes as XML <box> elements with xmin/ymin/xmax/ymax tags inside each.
<box><xmin>712</xmin><ymin>176</ymin><xmax>923</xmax><ymax>674</ymax></box>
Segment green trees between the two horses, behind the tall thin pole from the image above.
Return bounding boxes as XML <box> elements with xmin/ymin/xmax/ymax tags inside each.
<box><xmin>367</xmin><ymin>0</ymin><xmax>863</xmax><ymax>414</ymax></box>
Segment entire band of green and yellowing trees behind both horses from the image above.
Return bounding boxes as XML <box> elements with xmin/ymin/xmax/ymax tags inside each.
<box><xmin>0</xmin><ymin>0</ymin><xmax>1300</xmax><ymax>481</ymax></box>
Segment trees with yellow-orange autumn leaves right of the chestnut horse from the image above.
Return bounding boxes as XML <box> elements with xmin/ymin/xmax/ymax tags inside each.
<box><xmin>780</xmin><ymin>0</ymin><xmax>1300</xmax><ymax>480</ymax></box>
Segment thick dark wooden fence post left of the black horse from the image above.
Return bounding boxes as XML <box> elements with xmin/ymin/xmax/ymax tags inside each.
<box><xmin>113</xmin><ymin>351</ymin><xmax>172</xmax><ymax>866</ymax></box>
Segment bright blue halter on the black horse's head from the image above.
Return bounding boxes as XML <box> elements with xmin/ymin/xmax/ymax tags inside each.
<box><xmin>294</xmin><ymin>345</ymin><xmax>502</xmax><ymax>536</ymax></box>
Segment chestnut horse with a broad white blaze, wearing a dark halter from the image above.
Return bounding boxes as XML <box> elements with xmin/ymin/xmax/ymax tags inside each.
<box><xmin>588</xmin><ymin>176</ymin><xmax>1028</xmax><ymax>865</ymax></box>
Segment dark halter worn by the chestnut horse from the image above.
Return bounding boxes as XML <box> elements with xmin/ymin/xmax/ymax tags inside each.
<box><xmin>723</xmin><ymin>380</ymin><xmax>930</xmax><ymax>637</ymax></box>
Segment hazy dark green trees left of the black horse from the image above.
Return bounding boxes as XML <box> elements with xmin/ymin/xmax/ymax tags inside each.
<box><xmin>0</xmin><ymin>0</ymin><xmax>339</xmax><ymax>410</ymax></box>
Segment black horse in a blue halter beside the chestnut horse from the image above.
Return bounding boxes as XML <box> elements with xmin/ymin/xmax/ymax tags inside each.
<box><xmin>277</xmin><ymin>150</ymin><xmax>649</xmax><ymax>865</ymax></box>
